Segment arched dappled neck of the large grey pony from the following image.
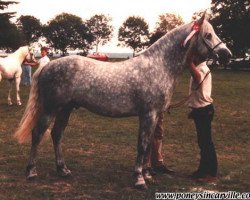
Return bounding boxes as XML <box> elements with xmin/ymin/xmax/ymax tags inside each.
<box><xmin>145</xmin><ymin>23</ymin><xmax>192</xmax><ymax>75</ymax></box>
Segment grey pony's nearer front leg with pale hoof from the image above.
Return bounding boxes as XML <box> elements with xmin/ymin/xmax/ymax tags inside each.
<box><xmin>135</xmin><ymin>112</ymin><xmax>157</xmax><ymax>189</ymax></box>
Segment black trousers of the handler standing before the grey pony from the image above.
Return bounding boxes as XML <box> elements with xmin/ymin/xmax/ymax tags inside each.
<box><xmin>192</xmin><ymin>104</ymin><xmax>218</xmax><ymax>176</ymax></box>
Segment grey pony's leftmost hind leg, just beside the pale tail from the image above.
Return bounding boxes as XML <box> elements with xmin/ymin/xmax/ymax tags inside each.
<box><xmin>26</xmin><ymin>114</ymin><xmax>50</xmax><ymax>179</ymax></box>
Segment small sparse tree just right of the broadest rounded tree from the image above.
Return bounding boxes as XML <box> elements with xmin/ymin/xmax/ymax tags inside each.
<box><xmin>86</xmin><ymin>14</ymin><xmax>113</xmax><ymax>52</ymax></box>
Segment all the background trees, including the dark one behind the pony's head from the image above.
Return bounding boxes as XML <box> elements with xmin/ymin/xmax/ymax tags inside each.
<box><xmin>0</xmin><ymin>0</ymin><xmax>250</xmax><ymax>56</ymax></box>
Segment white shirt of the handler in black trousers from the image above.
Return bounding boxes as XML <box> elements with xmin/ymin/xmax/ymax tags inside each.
<box><xmin>188</xmin><ymin>62</ymin><xmax>213</xmax><ymax>108</ymax></box>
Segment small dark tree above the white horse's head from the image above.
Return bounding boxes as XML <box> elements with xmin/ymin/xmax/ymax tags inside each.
<box><xmin>17</xmin><ymin>15</ymin><xmax>42</xmax><ymax>44</ymax></box>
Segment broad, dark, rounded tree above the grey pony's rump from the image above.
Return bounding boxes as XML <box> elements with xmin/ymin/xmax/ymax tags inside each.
<box><xmin>44</xmin><ymin>13</ymin><xmax>93</xmax><ymax>55</ymax></box>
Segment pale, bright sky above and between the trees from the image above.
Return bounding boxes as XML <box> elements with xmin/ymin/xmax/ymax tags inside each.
<box><xmin>8</xmin><ymin>0</ymin><xmax>211</xmax><ymax>52</ymax></box>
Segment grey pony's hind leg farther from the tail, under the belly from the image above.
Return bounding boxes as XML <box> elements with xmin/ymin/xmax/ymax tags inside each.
<box><xmin>51</xmin><ymin>106</ymin><xmax>73</xmax><ymax>177</ymax></box>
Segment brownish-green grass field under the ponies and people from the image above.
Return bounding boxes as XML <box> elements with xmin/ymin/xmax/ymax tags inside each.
<box><xmin>0</xmin><ymin>70</ymin><xmax>250</xmax><ymax>200</ymax></box>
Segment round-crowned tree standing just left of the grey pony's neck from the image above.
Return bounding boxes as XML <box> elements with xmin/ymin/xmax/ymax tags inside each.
<box><xmin>118</xmin><ymin>16</ymin><xmax>149</xmax><ymax>54</ymax></box>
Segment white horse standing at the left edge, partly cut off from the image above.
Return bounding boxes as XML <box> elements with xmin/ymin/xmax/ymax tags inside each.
<box><xmin>0</xmin><ymin>46</ymin><xmax>34</xmax><ymax>106</ymax></box>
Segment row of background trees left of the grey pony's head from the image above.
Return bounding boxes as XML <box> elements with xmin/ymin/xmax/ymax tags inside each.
<box><xmin>0</xmin><ymin>2</ymin><xmax>183</xmax><ymax>55</ymax></box>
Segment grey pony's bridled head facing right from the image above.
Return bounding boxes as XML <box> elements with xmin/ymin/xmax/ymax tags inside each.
<box><xmin>189</xmin><ymin>13</ymin><xmax>232</xmax><ymax>64</ymax></box>
